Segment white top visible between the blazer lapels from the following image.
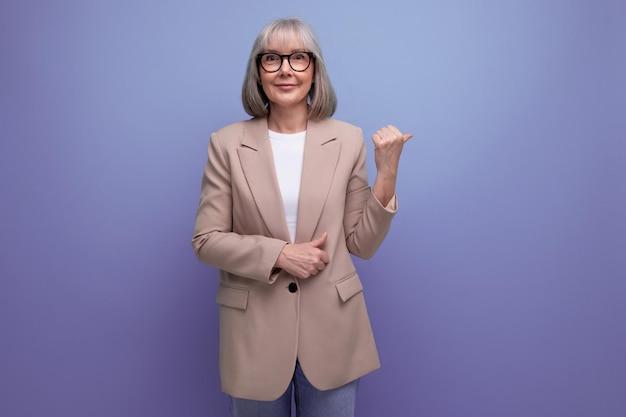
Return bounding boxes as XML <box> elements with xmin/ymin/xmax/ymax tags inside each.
<box><xmin>269</xmin><ymin>130</ymin><xmax>306</xmax><ymax>242</ymax></box>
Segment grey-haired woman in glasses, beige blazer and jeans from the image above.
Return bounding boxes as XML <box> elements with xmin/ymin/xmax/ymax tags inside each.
<box><xmin>192</xmin><ymin>19</ymin><xmax>412</xmax><ymax>417</ymax></box>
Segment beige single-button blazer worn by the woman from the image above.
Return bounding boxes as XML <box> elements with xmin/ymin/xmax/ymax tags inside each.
<box><xmin>192</xmin><ymin>118</ymin><xmax>395</xmax><ymax>401</ymax></box>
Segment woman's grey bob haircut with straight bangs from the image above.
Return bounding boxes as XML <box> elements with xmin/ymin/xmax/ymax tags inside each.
<box><xmin>241</xmin><ymin>18</ymin><xmax>337</xmax><ymax>120</ymax></box>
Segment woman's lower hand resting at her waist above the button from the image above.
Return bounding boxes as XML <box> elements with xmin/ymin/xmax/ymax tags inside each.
<box><xmin>274</xmin><ymin>232</ymin><xmax>330</xmax><ymax>279</ymax></box>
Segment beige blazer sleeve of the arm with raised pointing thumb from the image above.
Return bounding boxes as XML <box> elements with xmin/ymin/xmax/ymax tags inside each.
<box><xmin>344</xmin><ymin>129</ymin><xmax>396</xmax><ymax>259</ymax></box>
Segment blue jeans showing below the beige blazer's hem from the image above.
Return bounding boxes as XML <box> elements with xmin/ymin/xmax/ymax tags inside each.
<box><xmin>229</xmin><ymin>362</ymin><xmax>359</xmax><ymax>417</ymax></box>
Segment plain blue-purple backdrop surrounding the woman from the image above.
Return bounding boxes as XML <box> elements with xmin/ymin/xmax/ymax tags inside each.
<box><xmin>0</xmin><ymin>0</ymin><xmax>626</xmax><ymax>417</ymax></box>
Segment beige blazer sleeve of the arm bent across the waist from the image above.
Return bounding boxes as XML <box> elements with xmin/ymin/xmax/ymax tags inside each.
<box><xmin>192</xmin><ymin>133</ymin><xmax>287</xmax><ymax>284</ymax></box>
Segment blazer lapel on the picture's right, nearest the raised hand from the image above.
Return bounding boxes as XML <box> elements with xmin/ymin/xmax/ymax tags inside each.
<box><xmin>296</xmin><ymin>121</ymin><xmax>341</xmax><ymax>243</ymax></box>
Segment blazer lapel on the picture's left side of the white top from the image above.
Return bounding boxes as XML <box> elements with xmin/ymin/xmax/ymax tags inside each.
<box><xmin>237</xmin><ymin>118</ymin><xmax>291</xmax><ymax>242</ymax></box>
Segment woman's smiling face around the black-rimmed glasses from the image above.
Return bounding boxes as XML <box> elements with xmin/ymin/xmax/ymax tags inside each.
<box><xmin>259</xmin><ymin>35</ymin><xmax>315</xmax><ymax>109</ymax></box>
